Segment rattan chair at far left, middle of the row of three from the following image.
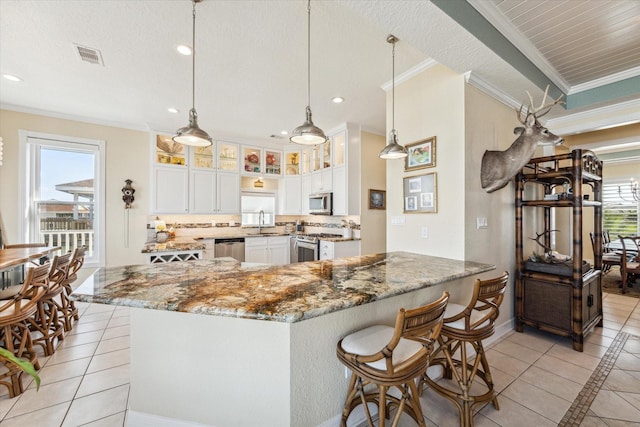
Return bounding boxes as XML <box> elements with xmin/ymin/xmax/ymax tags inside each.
<box><xmin>29</xmin><ymin>253</ymin><xmax>71</xmax><ymax>356</ymax></box>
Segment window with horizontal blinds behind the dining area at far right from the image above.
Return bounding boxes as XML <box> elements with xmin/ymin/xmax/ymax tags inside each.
<box><xmin>602</xmin><ymin>180</ymin><xmax>640</xmax><ymax>239</ymax></box>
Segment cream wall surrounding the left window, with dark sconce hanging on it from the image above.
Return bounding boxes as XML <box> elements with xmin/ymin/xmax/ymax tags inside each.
<box><xmin>0</xmin><ymin>110</ymin><xmax>150</xmax><ymax>266</ymax></box>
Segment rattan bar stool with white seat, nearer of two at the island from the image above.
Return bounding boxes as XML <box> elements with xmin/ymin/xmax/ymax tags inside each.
<box><xmin>337</xmin><ymin>292</ymin><xmax>449</xmax><ymax>427</ymax></box>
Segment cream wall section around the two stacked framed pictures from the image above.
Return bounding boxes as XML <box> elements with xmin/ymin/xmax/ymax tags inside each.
<box><xmin>387</xmin><ymin>65</ymin><xmax>466</xmax><ymax>259</ymax></box>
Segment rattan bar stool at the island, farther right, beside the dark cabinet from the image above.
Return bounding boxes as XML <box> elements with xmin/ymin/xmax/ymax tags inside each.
<box><xmin>419</xmin><ymin>271</ymin><xmax>509</xmax><ymax>427</ymax></box>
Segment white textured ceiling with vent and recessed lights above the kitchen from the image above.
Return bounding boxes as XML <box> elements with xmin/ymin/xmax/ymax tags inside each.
<box><xmin>0</xmin><ymin>0</ymin><xmax>640</xmax><ymax>145</ymax></box>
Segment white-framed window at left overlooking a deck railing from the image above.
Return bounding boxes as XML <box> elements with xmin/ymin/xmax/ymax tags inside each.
<box><xmin>20</xmin><ymin>132</ymin><xmax>104</xmax><ymax>266</ymax></box>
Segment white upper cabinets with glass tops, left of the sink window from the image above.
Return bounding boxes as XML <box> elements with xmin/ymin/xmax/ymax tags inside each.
<box><xmin>151</xmin><ymin>134</ymin><xmax>240</xmax><ymax>214</ymax></box>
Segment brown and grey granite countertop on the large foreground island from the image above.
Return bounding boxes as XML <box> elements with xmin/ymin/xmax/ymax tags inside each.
<box><xmin>72</xmin><ymin>252</ymin><xmax>495</xmax><ymax>323</ymax></box>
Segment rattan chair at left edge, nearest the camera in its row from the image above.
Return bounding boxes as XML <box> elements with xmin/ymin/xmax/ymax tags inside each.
<box><xmin>0</xmin><ymin>264</ymin><xmax>49</xmax><ymax>397</ymax></box>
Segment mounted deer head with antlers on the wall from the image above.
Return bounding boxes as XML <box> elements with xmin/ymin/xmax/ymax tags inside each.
<box><xmin>480</xmin><ymin>86</ymin><xmax>564</xmax><ymax>193</ymax></box>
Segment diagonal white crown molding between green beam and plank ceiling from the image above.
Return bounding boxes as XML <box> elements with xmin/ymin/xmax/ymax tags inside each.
<box><xmin>467</xmin><ymin>0</ymin><xmax>571</xmax><ymax>93</ymax></box>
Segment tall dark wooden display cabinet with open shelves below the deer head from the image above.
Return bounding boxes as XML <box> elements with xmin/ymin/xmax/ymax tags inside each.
<box><xmin>516</xmin><ymin>150</ymin><xmax>602</xmax><ymax>351</ymax></box>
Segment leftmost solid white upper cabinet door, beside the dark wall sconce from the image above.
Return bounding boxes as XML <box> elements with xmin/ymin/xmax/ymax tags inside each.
<box><xmin>153</xmin><ymin>167</ymin><xmax>189</xmax><ymax>213</ymax></box>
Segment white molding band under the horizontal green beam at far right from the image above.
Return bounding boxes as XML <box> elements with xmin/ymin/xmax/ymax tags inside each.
<box><xmin>545</xmin><ymin>99</ymin><xmax>640</xmax><ymax>135</ymax></box>
